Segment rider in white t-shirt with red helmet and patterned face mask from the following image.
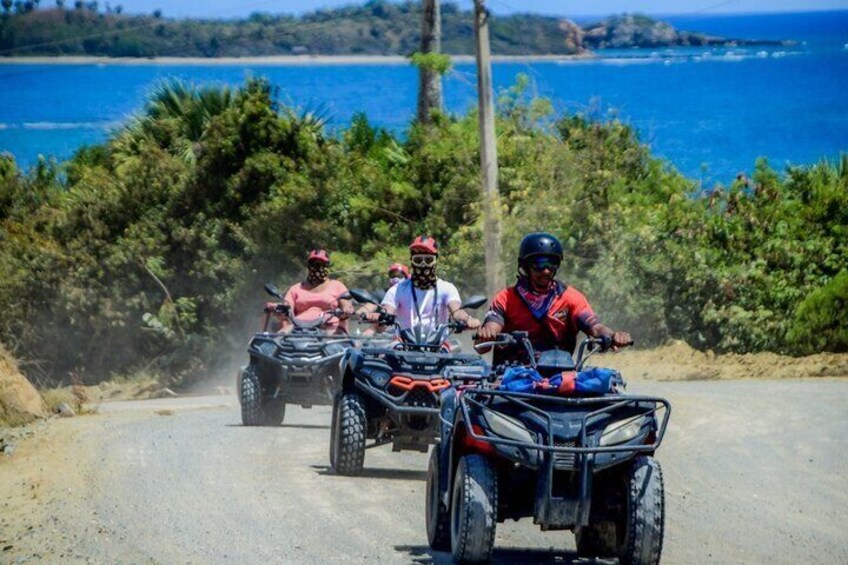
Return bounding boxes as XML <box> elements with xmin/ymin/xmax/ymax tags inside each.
<box><xmin>368</xmin><ymin>235</ymin><xmax>480</xmax><ymax>332</ymax></box>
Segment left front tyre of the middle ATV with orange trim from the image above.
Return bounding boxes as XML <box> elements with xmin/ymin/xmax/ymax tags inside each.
<box><xmin>330</xmin><ymin>393</ymin><xmax>368</xmax><ymax>475</ymax></box>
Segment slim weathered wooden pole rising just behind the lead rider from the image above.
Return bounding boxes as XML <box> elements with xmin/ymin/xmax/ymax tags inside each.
<box><xmin>474</xmin><ymin>0</ymin><xmax>503</xmax><ymax>296</ymax></box>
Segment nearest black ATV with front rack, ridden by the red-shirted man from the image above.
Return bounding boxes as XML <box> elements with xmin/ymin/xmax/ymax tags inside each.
<box><xmin>426</xmin><ymin>332</ymin><xmax>671</xmax><ymax>564</ymax></box>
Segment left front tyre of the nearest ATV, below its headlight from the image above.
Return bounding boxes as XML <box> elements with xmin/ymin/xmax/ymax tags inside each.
<box><xmin>450</xmin><ymin>455</ymin><xmax>498</xmax><ymax>563</ymax></box>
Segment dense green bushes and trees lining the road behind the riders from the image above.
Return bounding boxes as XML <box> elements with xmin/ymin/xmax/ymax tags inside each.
<box><xmin>0</xmin><ymin>78</ymin><xmax>848</xmax><ymax>385</ymax></box>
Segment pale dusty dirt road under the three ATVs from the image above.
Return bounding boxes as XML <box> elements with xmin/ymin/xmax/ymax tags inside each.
<box><xmin>0</xmin><ymin>378</ymin><xmax>848</xmax><ymax>563</ymax></box>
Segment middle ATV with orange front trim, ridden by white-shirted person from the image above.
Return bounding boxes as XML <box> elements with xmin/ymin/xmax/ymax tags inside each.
<box><xmin>330</xmin><ymin>290</ymin><xmax>488</xmax><ymax>475</ymax></box>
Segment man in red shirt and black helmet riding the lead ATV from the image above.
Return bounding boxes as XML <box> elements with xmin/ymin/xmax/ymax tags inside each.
<box><xmin>477</xmin><ymin>232</ymin><xmax>630</xmax><ymax>363</ymax></box>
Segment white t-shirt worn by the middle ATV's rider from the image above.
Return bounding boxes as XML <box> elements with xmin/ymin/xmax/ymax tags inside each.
<box><xmin>382</xmin><ymin>279</ymin><xmax>460</xmax><ymax>331</ymax></box>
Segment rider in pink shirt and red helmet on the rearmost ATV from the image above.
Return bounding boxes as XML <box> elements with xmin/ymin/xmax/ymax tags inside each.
<box><xmin>281</xmin><ymin>249</ymin><xmax>353</xmax><ymax>331</ymax></box>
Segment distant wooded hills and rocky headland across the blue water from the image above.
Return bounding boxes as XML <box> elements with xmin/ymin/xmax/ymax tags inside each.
<box><xmin>0</xmin><ymin>0</ymin><xmax>788</xmax><ymax>57</ymax></box>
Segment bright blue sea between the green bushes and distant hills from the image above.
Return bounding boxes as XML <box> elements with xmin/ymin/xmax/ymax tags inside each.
<box><xmin>0</xmin><ymin>11</ymin><xmax>848</xmax><ymax>185</ymax></box>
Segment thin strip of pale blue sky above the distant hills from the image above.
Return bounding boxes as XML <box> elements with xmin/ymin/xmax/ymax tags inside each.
<box><xmin>96</xmin><ymin>0</ymin><xmax>848</xmax><ymax>18</ymax></box>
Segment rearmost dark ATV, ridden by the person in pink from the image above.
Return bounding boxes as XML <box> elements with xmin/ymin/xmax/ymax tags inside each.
<box><xmin>236</xmin><ymin>285</ymin><xmax>353</xmax><ymax>426</ymax></box>
